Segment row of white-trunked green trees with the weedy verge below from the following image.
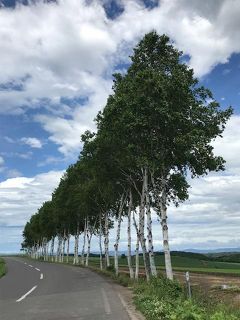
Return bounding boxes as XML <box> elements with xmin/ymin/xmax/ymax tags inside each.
<box><xmin>22</xmin><ymin>32</ymin><xmax>234</xmax><ymax>320</ymax></box>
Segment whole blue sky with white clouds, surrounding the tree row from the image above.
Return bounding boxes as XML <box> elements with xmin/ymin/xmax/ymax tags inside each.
<box><xmin>0</xmin><ymin>0</ymin><xmax>240</xmax><ymax>252</ymax></box>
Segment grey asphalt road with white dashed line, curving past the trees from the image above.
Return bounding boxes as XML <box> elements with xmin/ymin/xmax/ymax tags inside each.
<box><xmin>0</xmin><ymin>257</ymin><xmax>129</xmax><ymax>320</ymax></box>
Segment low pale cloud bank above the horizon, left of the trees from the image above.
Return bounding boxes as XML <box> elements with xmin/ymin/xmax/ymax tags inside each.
<box><xmin>0</xmin><ymin>171</ymin><xmax>63</xmax><ymax>253</ymax></box>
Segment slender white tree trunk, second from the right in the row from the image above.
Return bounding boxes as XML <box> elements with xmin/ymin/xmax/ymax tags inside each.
<box><xmin>144</xmin><ymin>168</ymin><xmax>157</xmax><ymax>277</ymax></box>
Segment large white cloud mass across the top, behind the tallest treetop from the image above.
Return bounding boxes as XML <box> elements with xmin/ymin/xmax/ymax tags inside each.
<box><xmin>0</xmin><ymin>0</ymin><xmax>240</xmax><ymax>154</ymax></box>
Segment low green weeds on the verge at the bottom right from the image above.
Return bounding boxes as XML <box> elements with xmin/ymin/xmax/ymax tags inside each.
<box><xmin>134</xmin><ymin>278</ymin><xmax>239</xmax><ymax>320</ymax></box>
